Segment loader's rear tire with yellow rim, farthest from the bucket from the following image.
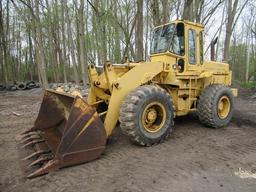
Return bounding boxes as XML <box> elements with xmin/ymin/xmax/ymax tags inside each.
<box><xmin>197</xmin><ymin>84</ymin><xmax>234</xmax><ymax>128</ymax></box>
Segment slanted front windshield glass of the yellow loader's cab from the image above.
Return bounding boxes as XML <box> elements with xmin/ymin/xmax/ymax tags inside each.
<box><xmin>150</xmin><ymin>24</ymin><xmax>175</xmax><ymax>54</ymax></box>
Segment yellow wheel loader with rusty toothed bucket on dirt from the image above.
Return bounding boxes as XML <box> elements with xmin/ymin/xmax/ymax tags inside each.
<box><xmin>18</xmin><ymin>20</ymin><xmax>237</xmax><ymax>178</ymax></box>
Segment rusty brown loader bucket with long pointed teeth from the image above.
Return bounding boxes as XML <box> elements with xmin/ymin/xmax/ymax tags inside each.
<box><xmin>18</xmin><ymin>90</ymin><xmax>106</xmax><ymax>178</ymax></box>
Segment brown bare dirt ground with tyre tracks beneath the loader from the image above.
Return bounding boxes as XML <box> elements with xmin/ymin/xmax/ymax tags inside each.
<box><xmin>0</xmin><ymin>87</ymin><xmax>256</xmax><ymax>192</ymax></box>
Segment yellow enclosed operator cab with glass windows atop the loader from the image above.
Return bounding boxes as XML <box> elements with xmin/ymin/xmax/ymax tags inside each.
<box><xmin>150</xmin><ymin>21</ymin><xmax>203</xmax><ymax>73</ymax></box>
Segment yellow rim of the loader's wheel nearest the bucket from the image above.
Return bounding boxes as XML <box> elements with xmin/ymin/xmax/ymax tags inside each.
<box><xmin>142</xmin><ymin>102</ymin><xmax>166</xmax><ymax>133</ymax></box>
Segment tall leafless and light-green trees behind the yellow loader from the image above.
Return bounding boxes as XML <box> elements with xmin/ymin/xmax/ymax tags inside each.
<box><xmin>0</xmin><ymin>0</ymin><xmax>256</xmax><ymax>87</ymax></box>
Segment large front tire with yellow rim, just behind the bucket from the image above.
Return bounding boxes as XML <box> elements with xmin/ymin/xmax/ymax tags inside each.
<box><xmin>119</xmin><ymin>85</ymin><xmax>173</xmax><ymax>146</ymax></box>
